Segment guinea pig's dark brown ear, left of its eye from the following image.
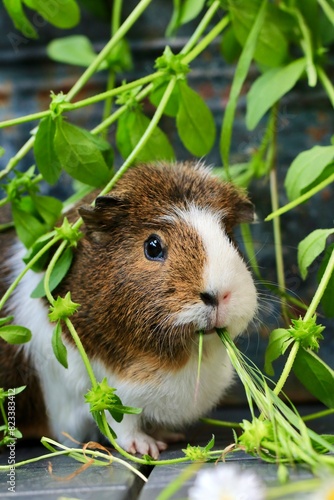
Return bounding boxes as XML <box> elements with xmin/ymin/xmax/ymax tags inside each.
<box><xmin>79</xmin><ymin>196</ymin><xmax>128</xmax><ymax>233</ymax></box>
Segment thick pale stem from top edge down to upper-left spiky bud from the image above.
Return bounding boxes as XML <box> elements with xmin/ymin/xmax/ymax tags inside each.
<box><xmin>66</xmin><ymin>0</ymin><xmax>152</xmax><ymax>101</ymax></box>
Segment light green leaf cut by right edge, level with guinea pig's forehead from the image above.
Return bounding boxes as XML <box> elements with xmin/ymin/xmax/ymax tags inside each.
<box><xmin>284</xmin><ymin>146</ymin><xmax>334</xmax><ymax>201</ymax></box>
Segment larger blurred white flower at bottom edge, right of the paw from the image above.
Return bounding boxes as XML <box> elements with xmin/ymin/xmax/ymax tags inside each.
<box><xmin>189</xmin><ymin>464</ymin><xmax>265</xmax><ymax>500</ymax></box>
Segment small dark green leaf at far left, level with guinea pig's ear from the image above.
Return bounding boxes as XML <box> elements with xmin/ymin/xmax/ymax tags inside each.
<box><xmin>12</xmin><ymin>203</ymin><xmax>46</xmax><ymax>248</ymax></box>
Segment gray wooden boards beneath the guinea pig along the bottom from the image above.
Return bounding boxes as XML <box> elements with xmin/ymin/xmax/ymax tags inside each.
<box><xmin>0</xmin><ymin>407</ymin><xmax>334</xmax><ymax>500</ymax></box>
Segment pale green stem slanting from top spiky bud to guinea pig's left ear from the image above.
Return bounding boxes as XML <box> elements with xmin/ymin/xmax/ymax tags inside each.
<box><xmin>101</xmin><ymin>76</ymin><xmax>177</xmax><ymax>195</ymax></box>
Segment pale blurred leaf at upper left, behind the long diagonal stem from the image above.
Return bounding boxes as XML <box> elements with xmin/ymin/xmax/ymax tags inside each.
<box><xmin>46</xmin><ymin>35</ymin><xmax>108</xmax><ymax>70</ymax></box>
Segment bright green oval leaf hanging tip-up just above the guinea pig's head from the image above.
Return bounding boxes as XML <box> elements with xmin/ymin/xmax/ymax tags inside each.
<box><xmin>176</xmin><ymin>81</ymin><xmax>216</xmax><ymax>156</ymax></box>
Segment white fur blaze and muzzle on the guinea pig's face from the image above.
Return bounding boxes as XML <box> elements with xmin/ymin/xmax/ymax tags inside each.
<box><xmin>164</xmin><ymin>205</ymin><xmax>257</xmax><ymax>337</ymax></box>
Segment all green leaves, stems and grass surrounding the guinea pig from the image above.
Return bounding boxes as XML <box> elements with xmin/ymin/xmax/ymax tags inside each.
<box><xmin>0</xmin><ymin>0</ymin><xmax>334</xmax><ymax>486</ymax></box>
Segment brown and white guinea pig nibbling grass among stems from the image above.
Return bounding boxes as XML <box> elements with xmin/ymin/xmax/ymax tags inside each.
<box><xmin>0</xmin><ymin>162</ymin><xmax>257</xmax><ymax>458</ymax></box>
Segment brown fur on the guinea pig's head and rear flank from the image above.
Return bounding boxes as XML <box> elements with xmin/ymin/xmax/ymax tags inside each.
<box><xmin>0</xmin><ymin>164</ymin><xmax>253</xmax><ymax>430</ymax></box>
